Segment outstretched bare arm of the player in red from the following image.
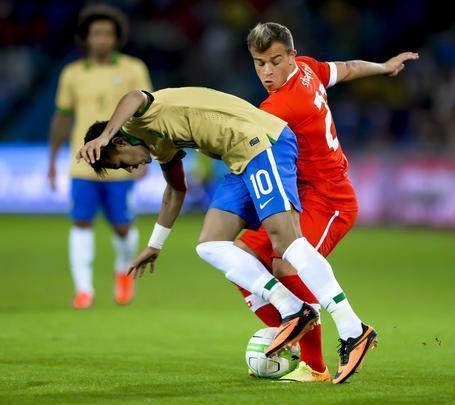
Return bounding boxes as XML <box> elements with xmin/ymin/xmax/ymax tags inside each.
<box><xmin>335</xmin><ymin>52</ymin><xmax>419</xmax><ymax>83</ymax></box>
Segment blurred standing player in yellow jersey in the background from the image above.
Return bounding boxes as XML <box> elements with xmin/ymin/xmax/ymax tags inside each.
<box><xmin>48</xmin><ymin>5</ymin><xmax>152</xmax><ymax>309</ymax></box>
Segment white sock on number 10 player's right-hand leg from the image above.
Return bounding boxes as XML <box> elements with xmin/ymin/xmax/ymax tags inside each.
<box><xmin>283</xmin><ymin>238</ymin><xmax>362</xmax><ymax>340</ymax></box>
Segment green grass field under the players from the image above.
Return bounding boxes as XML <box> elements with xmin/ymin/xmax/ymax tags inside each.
<box><xmin>0</xmin><ymin>216</ymin><xmax>455</xmax><ymax>404</ymax></box>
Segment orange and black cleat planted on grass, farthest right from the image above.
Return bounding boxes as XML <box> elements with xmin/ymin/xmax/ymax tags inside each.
<box><xmin>332</xmin><ymin>323</ymin><xmax>378</xmax><ymax>384</ymax></box>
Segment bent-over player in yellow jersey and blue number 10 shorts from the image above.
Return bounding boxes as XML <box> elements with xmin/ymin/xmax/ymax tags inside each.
<box><xmin>77</xmin><ymin>88</ymin><xmax>376</xmax><ymax>369</ymax></box>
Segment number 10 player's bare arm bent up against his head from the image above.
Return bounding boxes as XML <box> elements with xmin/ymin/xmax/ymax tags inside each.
<box><xmin>76</xmin><ymin>90</ymin><xmax>148</xmax><ymax>164</ymax></box>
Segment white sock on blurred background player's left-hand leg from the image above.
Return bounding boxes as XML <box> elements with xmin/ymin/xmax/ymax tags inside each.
<box><xmin>69</xmin><ymin>226</ymin><xmax>95</xmax><ymax>294</ymax></box>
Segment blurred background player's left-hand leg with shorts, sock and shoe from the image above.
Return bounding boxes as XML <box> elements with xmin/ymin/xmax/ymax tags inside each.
<box><xmin>69</xmin><ymin>179</ymin><xmax>99</xmax><ymax>309</ymax></box>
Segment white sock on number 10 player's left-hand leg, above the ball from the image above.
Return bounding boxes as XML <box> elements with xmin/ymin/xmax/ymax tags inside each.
<box><xmin>196</xmin><ymin>241</ymin><xmax>302</xmax><ymax>318</ymax></box>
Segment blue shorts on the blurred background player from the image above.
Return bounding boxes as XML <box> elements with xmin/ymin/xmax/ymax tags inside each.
<box><xmin>70</xmin><ymin>179</ymin><xmax>134</xmax><ymax>225</ymax></box>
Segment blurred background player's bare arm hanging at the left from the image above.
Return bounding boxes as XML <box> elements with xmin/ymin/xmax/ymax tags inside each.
<box><xmin>47</xmin><ymin>111</ymin><xmax>73</xmax><ymax>190</ymax></box>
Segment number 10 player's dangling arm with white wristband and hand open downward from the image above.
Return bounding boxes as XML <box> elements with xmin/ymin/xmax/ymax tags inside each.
<box><xmin>128</xmin><ymin>160</ymin><xmax>187</xmax><ymax>278</ymax></box>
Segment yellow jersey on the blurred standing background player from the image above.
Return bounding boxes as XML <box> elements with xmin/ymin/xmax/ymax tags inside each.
<box><xmin>56</xmin><ymin>53</ymin><xmax>152</xmax><ymax>181</ymax></box>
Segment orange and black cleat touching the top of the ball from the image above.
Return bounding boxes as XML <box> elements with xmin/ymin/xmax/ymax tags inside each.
<box><xmin>264</xmin><ymin>302</ymin><xmax>319</xmax><ymax>357</ymax></box>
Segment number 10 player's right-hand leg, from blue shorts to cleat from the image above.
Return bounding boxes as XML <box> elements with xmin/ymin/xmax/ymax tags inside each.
<box><xmin>248</xmin><ymin>130</ymin><xmax>376</xmax><ymax>383</ymax></box>
